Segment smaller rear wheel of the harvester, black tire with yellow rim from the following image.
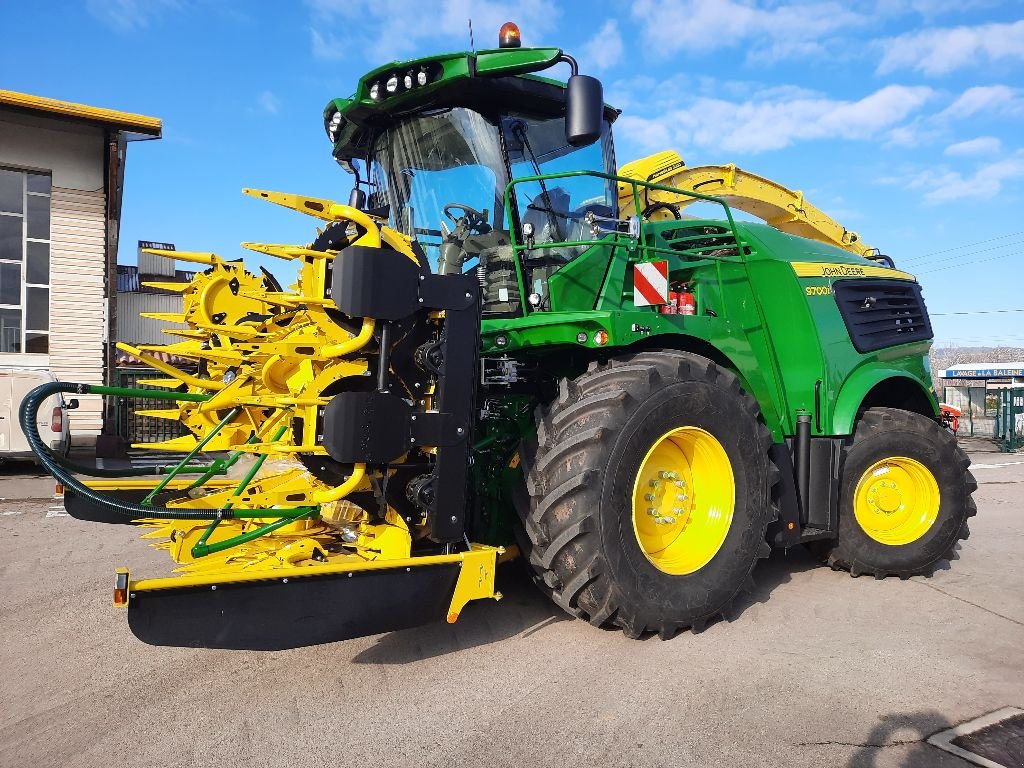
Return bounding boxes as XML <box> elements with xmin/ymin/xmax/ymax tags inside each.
<box><xmin>816</xmin><ymin>408</ymin><xmax>978</xmax><ymax>579</ymax></box>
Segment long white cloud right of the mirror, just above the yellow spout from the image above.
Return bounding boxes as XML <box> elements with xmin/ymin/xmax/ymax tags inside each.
<box><xmin>620</xmin><ymin>85</ymin><xmax>934</xmax><ymax>153</ymax></box>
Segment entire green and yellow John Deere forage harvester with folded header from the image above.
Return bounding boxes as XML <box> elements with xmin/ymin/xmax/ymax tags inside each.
<box><xmin>22</xmin><ymin>27</ymin><xmax>976</xmax><ymax>648</ymax></box>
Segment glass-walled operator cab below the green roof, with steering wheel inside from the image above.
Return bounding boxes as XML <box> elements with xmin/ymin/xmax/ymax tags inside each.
<box><xmin>367</xmin><ymin>78</ymin><xmax>616</xmax><ymax>315</ymax></box>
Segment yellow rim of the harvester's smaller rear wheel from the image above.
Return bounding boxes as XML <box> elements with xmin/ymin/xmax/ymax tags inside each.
<box><xmin>853</xmin><ymin>456</ymin><xmax>939</xmax><ymax>547</ymax></box>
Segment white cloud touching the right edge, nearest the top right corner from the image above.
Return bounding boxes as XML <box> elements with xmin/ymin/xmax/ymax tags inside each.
<box><xmin>878</xmin><ymin>20</ymin><xmax>1024</xmax><ymax>76</ymax></box>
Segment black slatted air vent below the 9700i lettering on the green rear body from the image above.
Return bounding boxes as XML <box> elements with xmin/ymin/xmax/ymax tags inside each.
<box><xmin>833</xmin><ymin>280</ymin><xmax>932</xmax><ymax>352</ymax></box>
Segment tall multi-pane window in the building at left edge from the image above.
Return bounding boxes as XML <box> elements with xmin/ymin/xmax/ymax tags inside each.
<box><xmin>0</xmin><ymin>168</ymin><xmax>51</xmax><ymax>354</ymax></box>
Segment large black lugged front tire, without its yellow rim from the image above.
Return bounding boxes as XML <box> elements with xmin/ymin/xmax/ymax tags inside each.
<box><xmin>520</xmin><ymin>350</ymin><xmax>778</xmax><ymax>638</ymax></box>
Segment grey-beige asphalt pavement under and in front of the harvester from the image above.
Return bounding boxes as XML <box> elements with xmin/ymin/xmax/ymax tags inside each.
<box><xmin>0</xmin><ymin>441</ymin><xmax>1024</xmax><ymax>768</ymax></box>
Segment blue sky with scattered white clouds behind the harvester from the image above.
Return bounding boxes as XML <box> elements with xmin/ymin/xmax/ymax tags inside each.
<box><xmin>0</xmin><ymin>0</ymin><xmax>1024</xmax><ymax>346</ymax></box>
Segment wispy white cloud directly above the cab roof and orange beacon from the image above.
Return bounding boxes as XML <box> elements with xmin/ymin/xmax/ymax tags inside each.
<box><xmin>306</xmin><ymin>0</ymin><xmax>559</xmax><ymax>63</ymax></box>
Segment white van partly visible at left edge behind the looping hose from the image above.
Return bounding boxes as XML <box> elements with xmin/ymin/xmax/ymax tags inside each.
<box><xmin>0</xmin><ymin>368</ymin><xmax>78</xmax><ymax>462</ymax></box>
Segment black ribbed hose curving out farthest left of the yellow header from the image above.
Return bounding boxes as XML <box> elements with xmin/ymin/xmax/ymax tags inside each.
<box><xmin>17</xmin><ymin>381</ymin><xmax>233</xmax><ymax>520</ymax></box>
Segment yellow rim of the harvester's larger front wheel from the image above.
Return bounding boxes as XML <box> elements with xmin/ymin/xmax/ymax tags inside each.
<box><xmin>633</xmin><ymin>427</ymin><xmax>736</xmax><ymax>575</ymax></box>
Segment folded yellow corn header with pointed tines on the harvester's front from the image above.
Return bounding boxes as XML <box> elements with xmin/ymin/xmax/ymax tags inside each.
<box><xmin>24</xmin><ymin>189</ymin><xmax>505</xmax><ymax>648</ymax></box>
